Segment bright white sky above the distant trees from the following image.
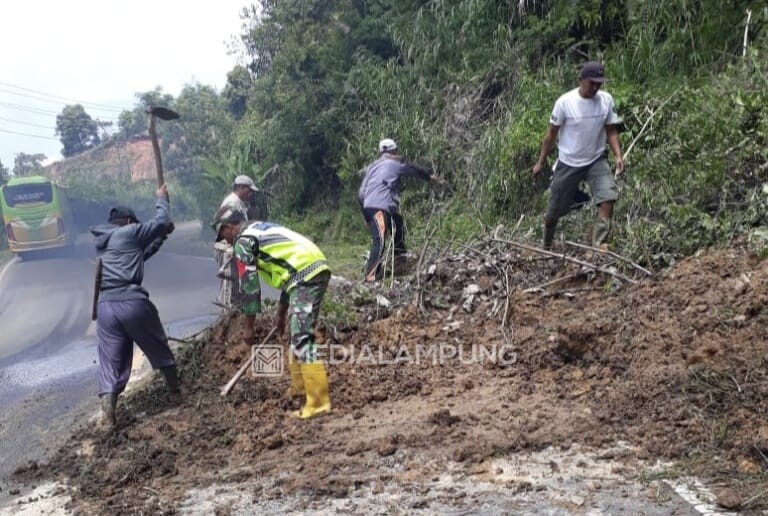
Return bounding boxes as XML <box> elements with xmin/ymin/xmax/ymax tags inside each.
<box><xmin>0</xmin><ymin>0</ymin><xmax>251</xmax><ymax>170</ymax></box>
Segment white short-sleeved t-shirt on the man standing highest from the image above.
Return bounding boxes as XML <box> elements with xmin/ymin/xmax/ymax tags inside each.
<box><xmin>549</xmin><ymin>88</ymin><xmax>619</xmax><ymax>167</ymax></box>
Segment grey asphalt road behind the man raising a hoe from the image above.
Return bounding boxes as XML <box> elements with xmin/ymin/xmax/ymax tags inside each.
<box><xmin>0</xmin><ymin>235</ymin><xmax>219</xmax><ymax>502</ymax></box>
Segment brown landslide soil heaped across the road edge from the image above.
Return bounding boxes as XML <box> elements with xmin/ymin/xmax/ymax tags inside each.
<box><xmin>12</xmin><ymin>241</ymin><xmax>768</xmax><ymax>514</ymax></box>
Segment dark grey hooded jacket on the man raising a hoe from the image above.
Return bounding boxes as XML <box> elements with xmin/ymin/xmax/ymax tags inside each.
<box><xmin>91</xmin><ymin>198</ymin><xmax>171</xmax><ymax>302</ymax></box>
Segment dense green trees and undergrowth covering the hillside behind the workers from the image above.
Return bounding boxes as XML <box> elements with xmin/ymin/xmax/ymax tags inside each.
<box><xmin>3</xmin><ymin>0</ymin><xmax>768</xmax><ymax>267</ymax></box>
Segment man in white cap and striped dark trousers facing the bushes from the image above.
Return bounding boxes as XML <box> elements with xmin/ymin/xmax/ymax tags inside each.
<box><xmin>357</xmin><ymin>138</ymin><xmax>438</xmax><ymax>282</ymax></box>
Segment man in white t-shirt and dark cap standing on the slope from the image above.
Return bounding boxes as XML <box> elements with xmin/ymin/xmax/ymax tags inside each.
<box><xmin>533</xmin><ymin>61</ymin><xmax>624</xmax><ymax>249</ymax></box>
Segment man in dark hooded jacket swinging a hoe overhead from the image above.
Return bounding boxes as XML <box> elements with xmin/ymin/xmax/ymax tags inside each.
<box><xmin>91</xmin><ymin>185</ymin><xmax>181</xmax><ymax>431</ymax></box>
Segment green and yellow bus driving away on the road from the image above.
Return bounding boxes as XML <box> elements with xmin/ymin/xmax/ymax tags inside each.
<box><xmin>0</xmin><ymin>176</ymin><xmax>77</xmax><ymax>257</ymax></box>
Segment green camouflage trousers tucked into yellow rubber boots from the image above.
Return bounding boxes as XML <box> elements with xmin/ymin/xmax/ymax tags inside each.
<box><xmin>288</xmin><ymin>271</ymin><xmax>331</xmax><ymax>364</ymax></box>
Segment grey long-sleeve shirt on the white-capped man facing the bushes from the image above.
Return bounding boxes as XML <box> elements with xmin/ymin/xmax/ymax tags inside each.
<box><xmin>357</xmin><ymin>153</ymin><xmax>430</xmax><ymax>213</ymax></box>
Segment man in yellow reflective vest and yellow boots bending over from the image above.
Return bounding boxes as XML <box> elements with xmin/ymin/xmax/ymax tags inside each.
<box><xmin>213</xmin><ymin>206</ymin><xmax>331</xmax><ymax>419</ymax></box>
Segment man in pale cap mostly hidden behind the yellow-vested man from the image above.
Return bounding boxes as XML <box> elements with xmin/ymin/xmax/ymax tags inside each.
<box><xmin>214</xmin><ymin>175</ymin><xmax>259</xmax><ymax>306</ymax></box>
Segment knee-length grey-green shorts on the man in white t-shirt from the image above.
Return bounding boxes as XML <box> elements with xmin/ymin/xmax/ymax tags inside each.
<box><xmin>547</xmin><ymin>157</ymin><xmax>619</xmax><ymax>219</ymax></box>
